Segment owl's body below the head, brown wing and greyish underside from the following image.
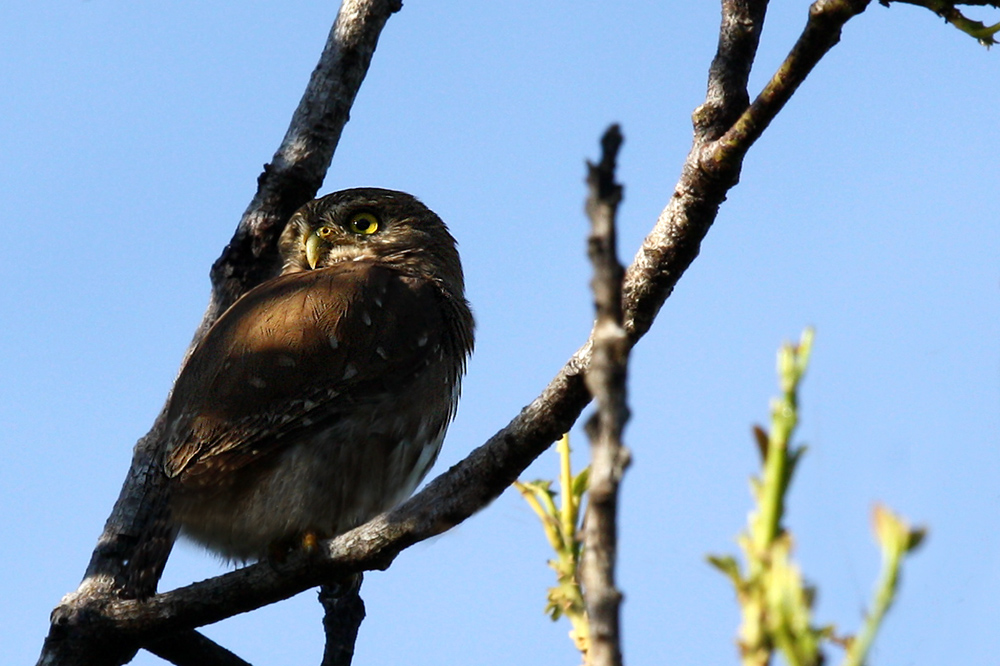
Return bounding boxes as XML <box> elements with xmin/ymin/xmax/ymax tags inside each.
<box><xmin>166</xmin><ymin>266</ymin><xmax>467</xmax><ymax>560</ymax></box>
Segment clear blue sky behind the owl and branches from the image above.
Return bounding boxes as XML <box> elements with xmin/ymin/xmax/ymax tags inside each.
<box><xmin>0</xmin><ymin>0</ymin><xmax>1000</xmax><ymax>665</ymax></box>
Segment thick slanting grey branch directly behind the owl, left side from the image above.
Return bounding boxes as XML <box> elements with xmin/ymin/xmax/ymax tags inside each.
<box><xmin>38</xmin><ymin>0</ymin><xmax>401</xmax><ymax>664</ymax></box>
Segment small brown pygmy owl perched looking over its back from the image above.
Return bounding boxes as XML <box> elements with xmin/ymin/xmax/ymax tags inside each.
<box><xmin>163</xmin><ymin>188</ymin><xmax>473</xmax><ymax>561</ymax></box>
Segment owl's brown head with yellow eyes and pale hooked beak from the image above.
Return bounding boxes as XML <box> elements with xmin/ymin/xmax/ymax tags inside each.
<box><xmin>278</xmin><ymin>187</ymin><xmax>464</xmax><ymax>295</ymax></box>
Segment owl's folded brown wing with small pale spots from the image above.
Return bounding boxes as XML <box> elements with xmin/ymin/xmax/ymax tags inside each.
<box><xmin>164</xmin><ymin>262</ymin><xmax>445</xmax><ymax>485</ymax></box>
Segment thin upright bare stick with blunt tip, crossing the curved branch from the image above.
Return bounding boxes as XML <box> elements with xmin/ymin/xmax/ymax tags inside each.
<box><xmin>582</xmin><ymin>125</ymin><xmax>629</xmax><ymax>666</ymax></box>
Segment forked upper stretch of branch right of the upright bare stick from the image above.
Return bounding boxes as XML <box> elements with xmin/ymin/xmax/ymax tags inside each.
<box><xmin>624</xmin><ymin>0</ymin><xmax>869</xmax><ymax>341</ymax></box>
